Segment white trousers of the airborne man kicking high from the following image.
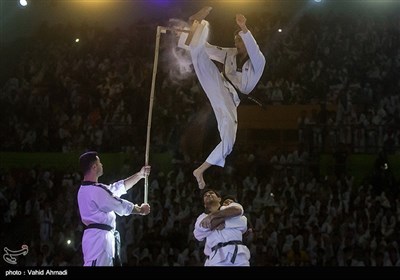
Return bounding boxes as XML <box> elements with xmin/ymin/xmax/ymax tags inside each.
<box><xmin>190</xmin><ymin>23</ymin><xmax>237</xmax><ymax>167</ymax></box>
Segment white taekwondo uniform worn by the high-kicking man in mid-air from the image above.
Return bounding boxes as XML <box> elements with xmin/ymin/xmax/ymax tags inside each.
<box><xmin>178</xmin><ymin>20</ymin><xmax>265</xmax><ymax>167</ymax></box>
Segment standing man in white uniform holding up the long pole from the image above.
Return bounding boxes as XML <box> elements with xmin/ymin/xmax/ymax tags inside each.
<box><xmin>78</xmin><ymin>151</ymin><xmax>151</xmax><ymax>266</ymax></box>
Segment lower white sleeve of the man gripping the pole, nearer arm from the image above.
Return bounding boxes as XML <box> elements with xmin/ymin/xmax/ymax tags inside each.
<box><xmin>92</xmin><ymin>188</ymin><xmax>133</xmax><ymax>216</ymax></box>
